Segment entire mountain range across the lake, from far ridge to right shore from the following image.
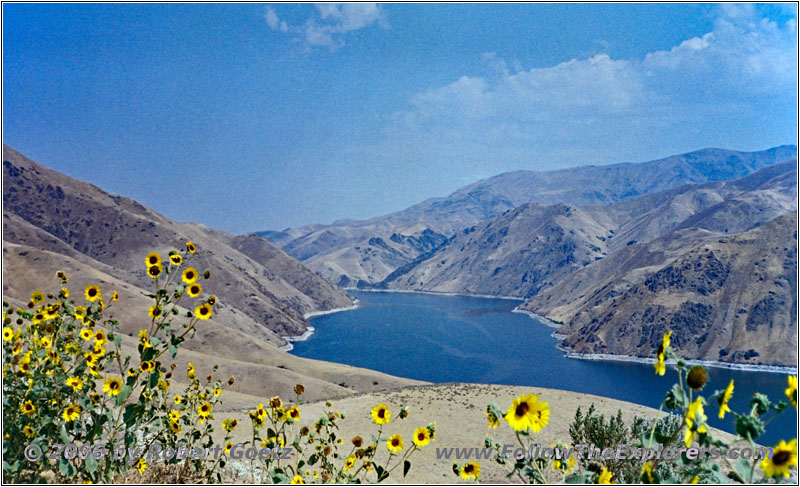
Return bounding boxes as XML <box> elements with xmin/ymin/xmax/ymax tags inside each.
<box><xmin>268</xmin><ymin>146</ymin><xmax>797</xmax><ymax>366</ymax></box>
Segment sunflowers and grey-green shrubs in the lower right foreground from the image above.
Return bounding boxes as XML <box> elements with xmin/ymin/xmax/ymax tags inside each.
<box><xmin>460</xmin><ymin>332</ymin><xmax>797</xmax><ymax>484</ymax></box>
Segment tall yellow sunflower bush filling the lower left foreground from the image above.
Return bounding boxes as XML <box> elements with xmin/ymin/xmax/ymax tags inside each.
<box><xmin>3</xmin><ymin>242</ymin><xmax>436</xmax><ymax>483</ymax></box>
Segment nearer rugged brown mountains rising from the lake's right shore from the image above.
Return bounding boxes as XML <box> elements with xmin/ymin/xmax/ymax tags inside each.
<box><xmin>382</xmin><ymin>160</ymin><xmax>797</xmax><ymax>367</ymax></box>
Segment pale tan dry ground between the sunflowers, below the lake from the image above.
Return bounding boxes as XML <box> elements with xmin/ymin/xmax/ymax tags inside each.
<box><xmin>208</xmin><ymin>384</ymin><xmax>730</xmax><ymax>483</ymax></box>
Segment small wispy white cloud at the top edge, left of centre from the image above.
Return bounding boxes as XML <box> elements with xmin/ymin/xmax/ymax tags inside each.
<box><xmin>265</xmin><ymin>3</ymin><xmax>387</xmax><ymax>50</ymax></box>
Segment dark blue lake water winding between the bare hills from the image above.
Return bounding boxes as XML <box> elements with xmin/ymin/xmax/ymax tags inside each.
<box><xmin>292</xmin><ymin>291</ymin><xmax>797</xmax><ymax>444</ymax></box>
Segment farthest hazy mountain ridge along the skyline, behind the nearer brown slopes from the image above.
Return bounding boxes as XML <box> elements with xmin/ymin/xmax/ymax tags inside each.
<box><xmin>261</xmin><ymin>146</ymin><xmax>797</xmax><ymax>286</ymax></box>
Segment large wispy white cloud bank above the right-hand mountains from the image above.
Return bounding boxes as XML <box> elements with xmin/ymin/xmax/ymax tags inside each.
<box><xmin>385</xmin><ymin>4</ymin><xmax>797</xmax><ymax>167</ymax></box>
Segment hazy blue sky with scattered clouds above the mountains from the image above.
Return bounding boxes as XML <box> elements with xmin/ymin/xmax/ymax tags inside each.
<box><xmin>3</xmin><ymin>3</ymin><xmax>797</xmax><ymax>232</ymax></box>
